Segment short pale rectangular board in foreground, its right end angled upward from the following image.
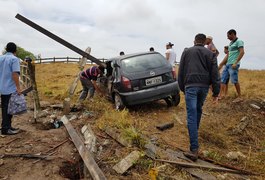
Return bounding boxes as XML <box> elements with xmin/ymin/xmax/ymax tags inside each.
<box><xmin>113</xmin><ymin>151</ymin><xmax>141</xmax><ymax>174</ymax></box>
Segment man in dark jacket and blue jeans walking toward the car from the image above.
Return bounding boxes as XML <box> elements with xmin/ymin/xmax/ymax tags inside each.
<box><xmin>178</xmin><ymin>34</ymin><xmax>220</xmax><ymax>161</ymax></box>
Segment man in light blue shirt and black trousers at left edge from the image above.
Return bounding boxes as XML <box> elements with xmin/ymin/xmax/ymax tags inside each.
<box><xmin>0</xmin><ymin>42</ymin><xmax>21</xmax><ymax>135</ymax></box>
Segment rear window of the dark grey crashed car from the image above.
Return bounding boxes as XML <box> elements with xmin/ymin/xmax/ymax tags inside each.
<box><xmin>121</xmin><ymin>54</ymin><xmax>167</xmax><ymax>73</ymax></box>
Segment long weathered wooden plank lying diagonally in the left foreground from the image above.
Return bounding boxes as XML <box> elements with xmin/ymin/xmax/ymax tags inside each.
<box><xmin>61</xmin><ymin>116</ymin><xmax>106</xmax><ymax>180</ymax></box>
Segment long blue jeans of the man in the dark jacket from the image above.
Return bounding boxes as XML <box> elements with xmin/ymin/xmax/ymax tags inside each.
<box><xmin>185</xmin><ymin>87</ymin><xmax>209</xmax><ymax>151</ymax></box>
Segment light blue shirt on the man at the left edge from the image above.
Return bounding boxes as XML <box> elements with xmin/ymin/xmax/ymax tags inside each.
<box><xmin>0</xmin><ymin>52</ymin><xmax>20</xmax><ymax>95</ymax></box>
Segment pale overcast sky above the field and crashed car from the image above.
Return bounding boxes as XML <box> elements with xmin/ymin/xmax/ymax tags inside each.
<box><xmin>0</xmin><ymin>0</ymin><xmax>265</xmax><ymax>70</ymax></box>
